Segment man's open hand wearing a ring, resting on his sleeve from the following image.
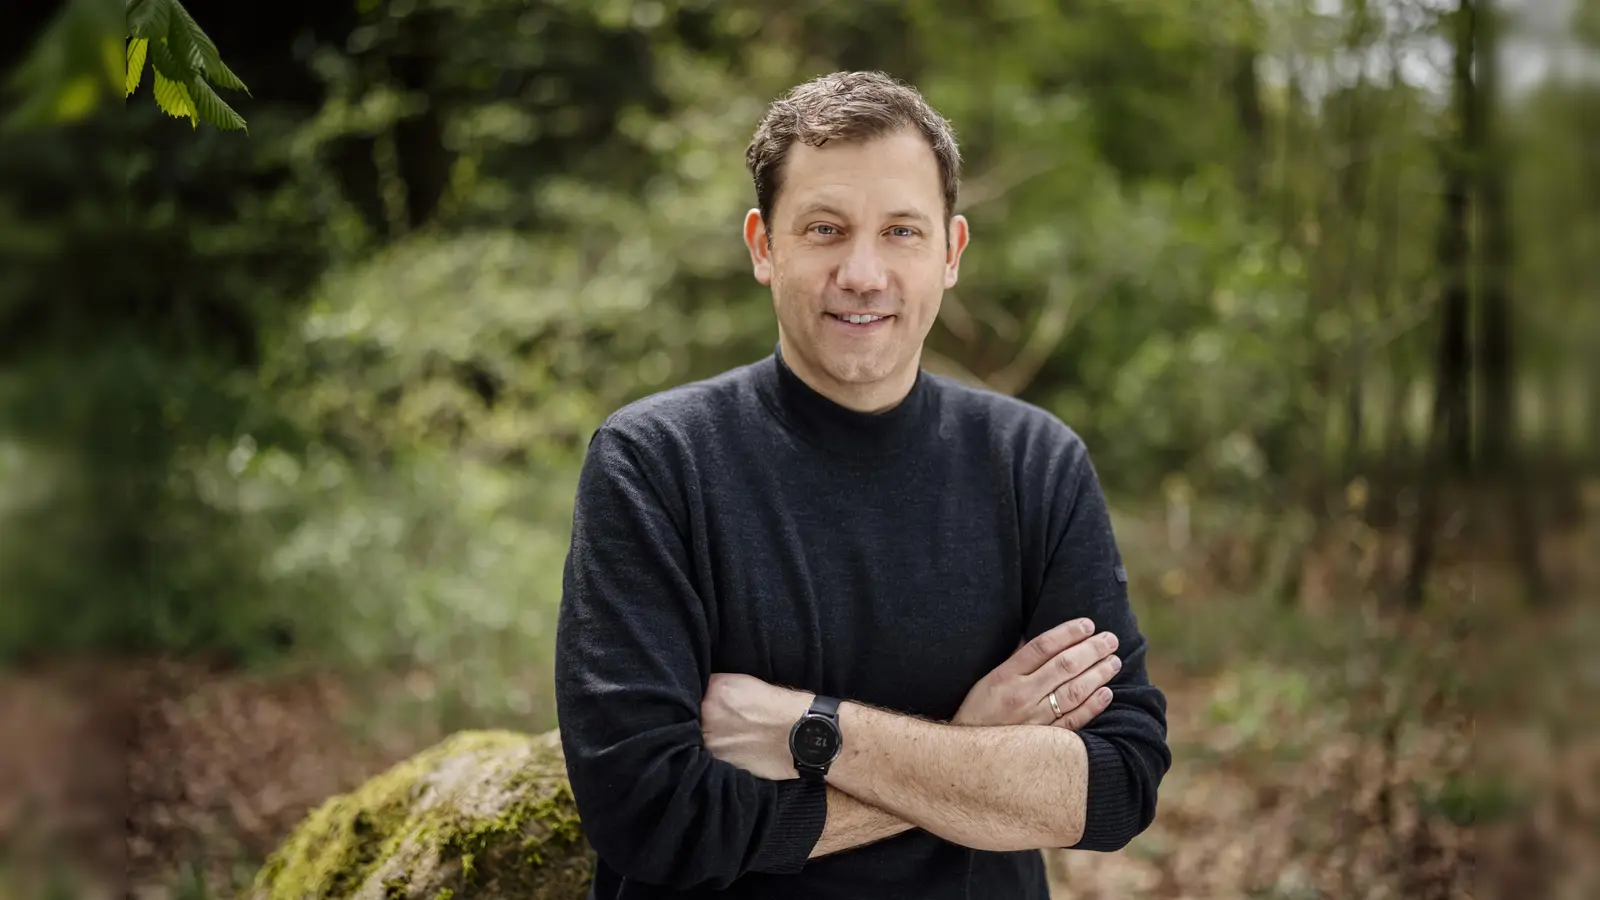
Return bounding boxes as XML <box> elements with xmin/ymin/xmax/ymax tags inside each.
<box><xmin>950</xmin><ymin>618</ymin><xmax>1122</xmax><ymax>730</ymax></box>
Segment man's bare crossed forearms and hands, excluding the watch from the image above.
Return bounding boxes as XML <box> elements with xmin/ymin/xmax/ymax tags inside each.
<box><xmin>701</xmin><ymin>620</ymin><xmax>1122</xmax><ymax>858</ymax></box>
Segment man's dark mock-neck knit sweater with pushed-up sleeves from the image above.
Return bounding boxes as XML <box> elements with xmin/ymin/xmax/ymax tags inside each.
<box><xmin>555</xmin><ymin>352</ymin><xmax>1171</xmax><ymax>900</ymax></box>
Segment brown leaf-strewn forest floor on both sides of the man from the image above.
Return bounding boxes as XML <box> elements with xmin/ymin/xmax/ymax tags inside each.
<box><xmin>0</xmin><ymin>512</ymin><xmax>1600</xmax><ymax>900</ymax></box>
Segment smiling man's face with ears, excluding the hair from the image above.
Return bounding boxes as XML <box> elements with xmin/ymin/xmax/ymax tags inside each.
<box><xmin>744</xmin><ymin>130</ymin><xmax>968</xmax><ymax>410</ymax></box>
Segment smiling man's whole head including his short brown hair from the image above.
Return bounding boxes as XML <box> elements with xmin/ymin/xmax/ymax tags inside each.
<box><xmin>744</xmin><ymin>72</ymin><xmax>968</xmax><ymax>410</ymax></box>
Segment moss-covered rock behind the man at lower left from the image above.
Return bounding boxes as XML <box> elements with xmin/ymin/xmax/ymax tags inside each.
<box><xmin>248</xmin><ymin>732</ymin><xmax>594</xmax><ymax>900</ymax></box>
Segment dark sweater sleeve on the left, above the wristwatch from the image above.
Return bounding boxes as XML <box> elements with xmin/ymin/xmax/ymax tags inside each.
<box><xmin>555</xmin><ymin>426</ymin><xmax>827</xmax><ymax>889</ymax></box>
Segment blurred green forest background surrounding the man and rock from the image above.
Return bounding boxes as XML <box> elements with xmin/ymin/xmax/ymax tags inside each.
<box><xmin>0</xmin><ymin>0</ymin><xmax>1600</xmax><ymax>898</ymax></box>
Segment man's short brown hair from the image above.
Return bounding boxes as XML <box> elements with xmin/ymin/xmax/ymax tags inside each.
<box><xmin>744</xmin><ymin>72</ymin><xmax>962</xmax><ymax>234</ymax></box>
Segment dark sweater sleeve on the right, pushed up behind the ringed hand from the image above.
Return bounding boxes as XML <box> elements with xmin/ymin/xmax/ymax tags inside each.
<box><xmin>1027</xmin><ymin>440</ymin><xmax>1173</xmax><ymax>852</ymax></box>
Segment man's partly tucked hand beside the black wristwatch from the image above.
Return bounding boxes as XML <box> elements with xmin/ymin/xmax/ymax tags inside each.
<box><xmin>701</xmin><ymin>673</ymin><xmax>813</xmax><ymax>781</ymax></box>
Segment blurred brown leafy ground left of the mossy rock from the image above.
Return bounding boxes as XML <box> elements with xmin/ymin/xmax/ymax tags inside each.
<box><xmin>0</xmin><ymin>663</ymin><xmax>427</xmax><ymax>900</ymax></box>
